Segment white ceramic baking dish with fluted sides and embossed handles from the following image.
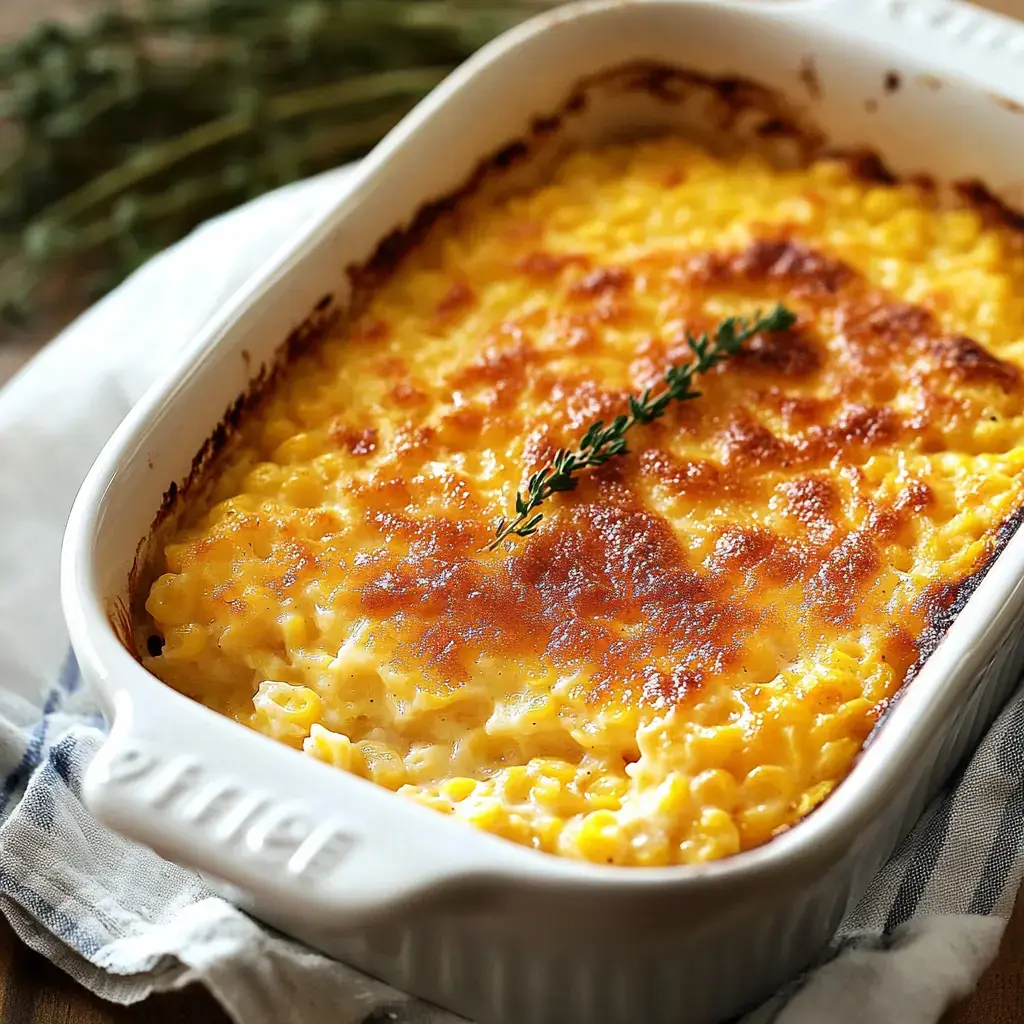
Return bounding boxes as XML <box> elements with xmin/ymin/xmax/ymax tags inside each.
<box><xmin>62</xmin><ymin>0</ymin><xmax>1024</xmax><ymax>1024</ymax></box>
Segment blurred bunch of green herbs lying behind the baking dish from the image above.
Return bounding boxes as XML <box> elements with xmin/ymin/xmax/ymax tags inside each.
<box><xmin>0</xmin><ymin>0</ymin><xmax>553</xmax><ymax>317</ymax></box>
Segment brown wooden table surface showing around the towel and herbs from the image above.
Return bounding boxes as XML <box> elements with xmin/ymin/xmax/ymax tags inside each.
<box><xmin>8</xmin><ymin>0</ymin><xmax>1024</xmax><ymax>1024</ymax></box>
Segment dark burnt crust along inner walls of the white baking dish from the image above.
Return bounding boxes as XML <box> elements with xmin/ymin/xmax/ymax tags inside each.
<box><xmin>116</xmin><ymin>60</ymin><xmax>1024</xmax><ymax>885</ymax></box>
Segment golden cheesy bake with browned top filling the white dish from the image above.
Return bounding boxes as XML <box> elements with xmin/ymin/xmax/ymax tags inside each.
<box><xmin>136</xmin><ymin>130</ymin><xmax>1024</xmax><ymax>865</ymax></box>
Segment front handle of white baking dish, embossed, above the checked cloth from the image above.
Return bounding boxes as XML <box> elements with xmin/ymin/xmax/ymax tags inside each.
<box><xmin>83</xmin><ymin>693</ymin><xmax>495</xmax><ymax>931</ymax></box>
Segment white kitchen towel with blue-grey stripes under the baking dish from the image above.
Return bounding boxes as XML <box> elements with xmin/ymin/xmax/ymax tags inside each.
<box><xmin>0</xmin><ymin>159</ymin><xmax>1024</xmax><ymax>1024</ymax></box>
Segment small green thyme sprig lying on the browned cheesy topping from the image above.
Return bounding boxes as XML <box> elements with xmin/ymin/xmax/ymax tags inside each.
<box><xmin>486</xmin><ymin>305</ymin><xmax>797</xmax><ymax>551</ymax></box>
